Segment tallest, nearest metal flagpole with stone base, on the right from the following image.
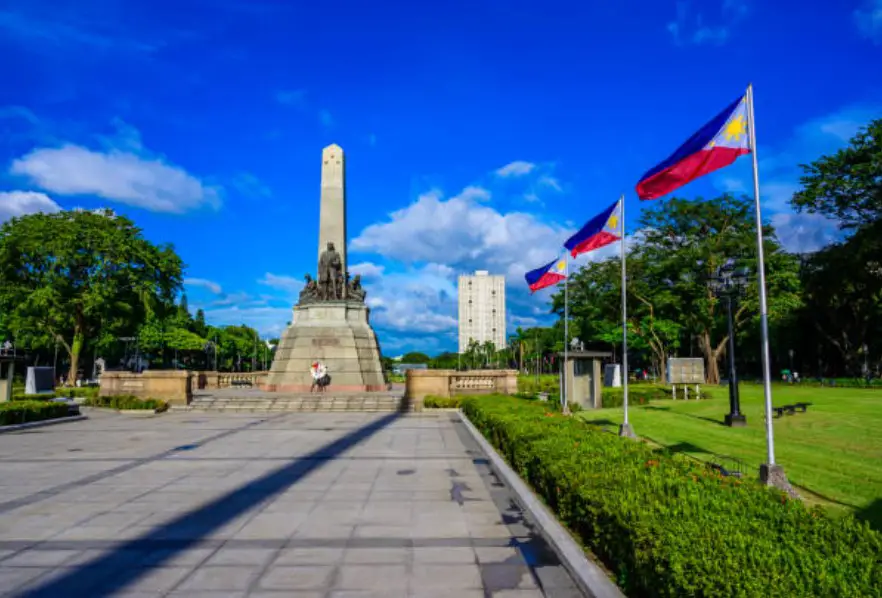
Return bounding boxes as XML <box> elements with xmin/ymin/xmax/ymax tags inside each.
<box><xmin>747</xmin><ymin>83</ymin><xmax>792</xmax><ymax>490</ymax></box>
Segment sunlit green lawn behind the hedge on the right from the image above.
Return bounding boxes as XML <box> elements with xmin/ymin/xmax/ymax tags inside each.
<box><xmin>579</xmin><ymin>385</ymin><xmax>882</xmax><ymax>529</ymax></box>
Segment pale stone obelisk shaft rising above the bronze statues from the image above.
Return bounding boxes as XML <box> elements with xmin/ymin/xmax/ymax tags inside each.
<box><xmin>318</xmin><ymin>143</ymin><xmax>346</xmax><ymax>272</ymax></box>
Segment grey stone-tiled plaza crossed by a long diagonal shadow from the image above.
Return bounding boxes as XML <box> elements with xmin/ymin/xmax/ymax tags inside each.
<box><xmin>0</xmin><ymin>410</ymin><xmax>581</xmax><ymax>598</ymax></box>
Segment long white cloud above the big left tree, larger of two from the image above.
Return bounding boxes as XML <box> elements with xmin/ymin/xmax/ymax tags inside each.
<box><xmin>10</xmin><ymin>121</ymin><xmax>221</xmax><ymax>213</ymax></box>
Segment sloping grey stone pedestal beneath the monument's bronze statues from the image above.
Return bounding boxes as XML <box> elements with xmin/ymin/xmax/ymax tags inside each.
<box><xmin>263</xmin><ymin>300</ymin><xmax>388</xmax><ymax>393</ymax></box>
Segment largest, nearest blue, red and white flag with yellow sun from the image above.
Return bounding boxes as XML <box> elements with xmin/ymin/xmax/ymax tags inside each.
<box><xmin>637</xmin><ymin>96</ymin><xmax>750</xmax><ymax>199</ymax></box>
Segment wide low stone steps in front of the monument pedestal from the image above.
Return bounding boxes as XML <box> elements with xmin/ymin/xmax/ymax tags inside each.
<box><xmin>171</xmin><ymin>393</ymin><xmax>410</xmax><ymax>413</ymax></box>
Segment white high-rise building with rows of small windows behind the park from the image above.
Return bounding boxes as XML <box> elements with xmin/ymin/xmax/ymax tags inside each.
<box><xmin>459</xmin><ymin>270</ymin><xmax>506</xmax><ymax>353</ymax></box>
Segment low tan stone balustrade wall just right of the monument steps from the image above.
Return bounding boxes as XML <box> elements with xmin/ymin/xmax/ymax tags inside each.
<box><xmin>404</xmin><ymin>370</ymin><xmax>518</xmax><ymax>404</ymax></box>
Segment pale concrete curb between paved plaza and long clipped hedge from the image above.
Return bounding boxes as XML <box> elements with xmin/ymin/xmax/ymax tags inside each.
<box><xmin>457</xmin><ymin>411</ymin><xmax>625</xmax><ymax>598</ymax></box>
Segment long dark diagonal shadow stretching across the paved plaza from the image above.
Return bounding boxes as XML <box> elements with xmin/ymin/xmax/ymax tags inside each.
<box><xmin>18</xmin><ymin>413</ymin><xmax>401</xmax><ymax>598</ymax></box>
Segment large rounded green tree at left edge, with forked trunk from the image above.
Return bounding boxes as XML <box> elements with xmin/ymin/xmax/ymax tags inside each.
<box><xmin>0</xmin><ymin>211</ymin><xmax>183</xmax><ymax>380</ymax></box>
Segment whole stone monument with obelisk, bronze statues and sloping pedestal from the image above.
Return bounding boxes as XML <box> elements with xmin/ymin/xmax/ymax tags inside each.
<box><xmin>264</xmin><ymin>144</ymin><xmax>388</xmax><ymax>393</ymax></box>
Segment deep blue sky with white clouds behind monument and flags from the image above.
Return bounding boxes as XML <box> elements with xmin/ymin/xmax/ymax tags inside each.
<box><xmin>0</xmin><ymin>0</ymin><xmax>882</xmax><ymax>355</ymax></box>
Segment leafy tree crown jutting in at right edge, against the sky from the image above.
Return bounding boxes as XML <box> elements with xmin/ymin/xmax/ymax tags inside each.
<box><xmin>791</xmin><ymin>119</ymin><xmax>882</xmax><ymax>229</ymax></box>
